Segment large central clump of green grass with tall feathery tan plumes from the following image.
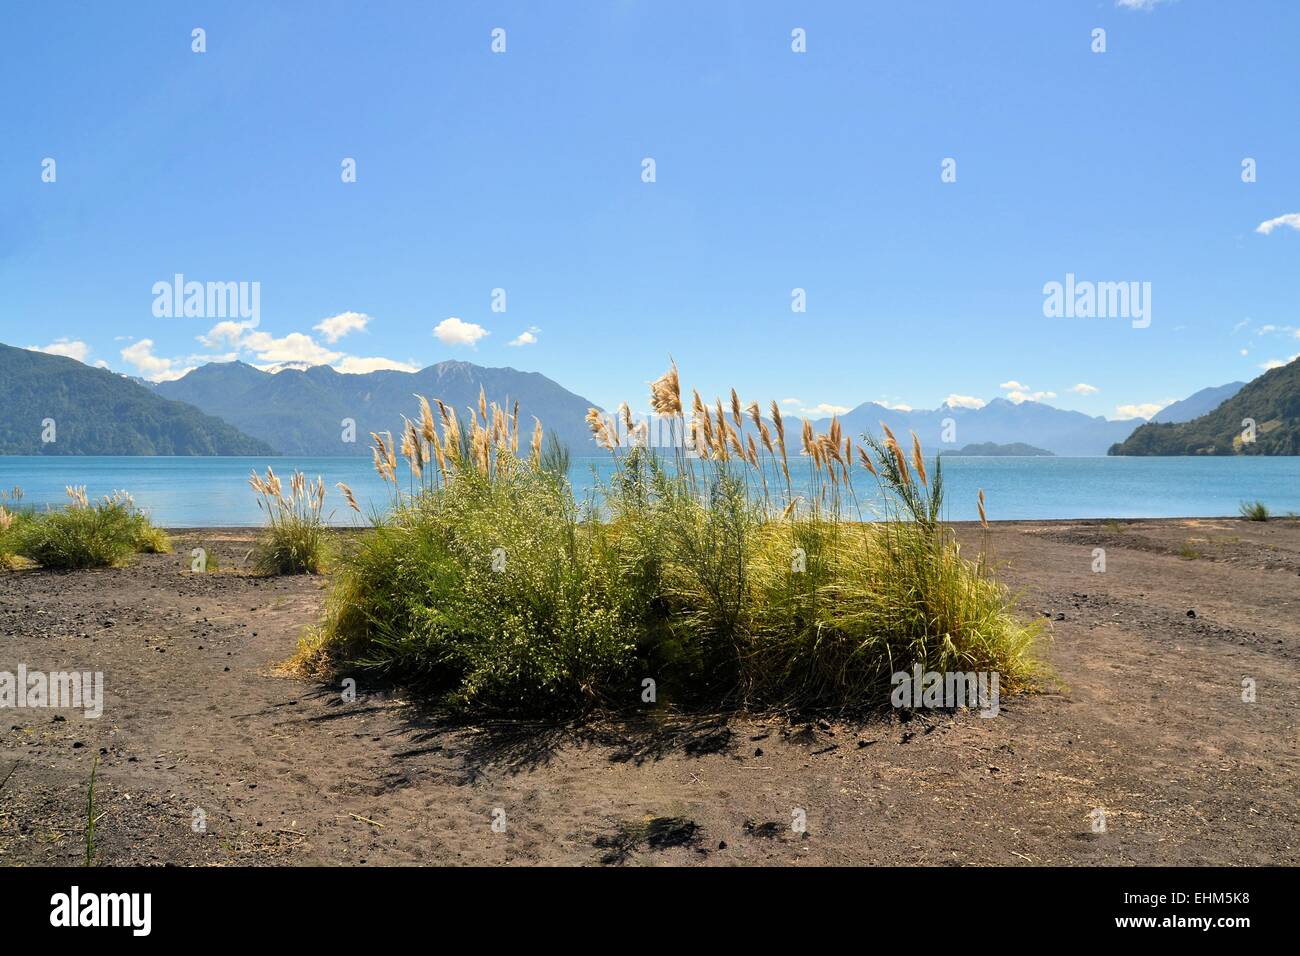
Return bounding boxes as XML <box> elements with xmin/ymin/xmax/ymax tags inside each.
<box><xmin>296</xmin><ymin>369</ymin><xmax>1037</xmax><ymax>713</ymax></box>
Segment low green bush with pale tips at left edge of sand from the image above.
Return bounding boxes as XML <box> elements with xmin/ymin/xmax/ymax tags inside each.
<box><xmin>12</xmin><ymin>488</ymin><xmax>170</xmax><ymax>570</ymax></box>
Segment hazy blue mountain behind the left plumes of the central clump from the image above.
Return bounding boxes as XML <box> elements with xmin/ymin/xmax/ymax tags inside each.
<box><xmin>155</xmin><ymin>362</ymin><xmax>592</xmax><ymax>457</ymax></box>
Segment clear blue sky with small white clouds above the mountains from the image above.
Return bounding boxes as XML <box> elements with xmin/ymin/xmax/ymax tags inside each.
<box><xmin>0</xmin><ymin>0</ymin><xmax>1300</xmax><ymax>418</ymax></box>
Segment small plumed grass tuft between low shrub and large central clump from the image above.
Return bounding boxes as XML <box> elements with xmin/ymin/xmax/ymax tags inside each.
<box><xmin>248</xmin><ymin>468</ymin><xmax>325</xmax><ymax>575</ymax></box>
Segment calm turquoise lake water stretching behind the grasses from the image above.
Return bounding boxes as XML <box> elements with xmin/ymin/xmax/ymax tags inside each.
<box><xmin>0</xmin><ymin>455</ymin><xmax>1300</xmax><ymax>528</ymax></box>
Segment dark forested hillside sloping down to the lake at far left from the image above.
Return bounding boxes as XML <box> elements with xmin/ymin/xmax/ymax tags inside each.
<box><xmin>0</xmin><ymin>345</ymin><xmax>274</xmax><ymax>455</ymax></box>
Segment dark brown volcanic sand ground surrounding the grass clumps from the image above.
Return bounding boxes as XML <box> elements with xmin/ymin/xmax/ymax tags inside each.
<box><xmin>0</xmin><ymin>519</ymin><xmax>1300</xmax><ymax>865</ymax></box>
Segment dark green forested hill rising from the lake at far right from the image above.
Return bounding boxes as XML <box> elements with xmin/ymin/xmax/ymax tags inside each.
<box><xmin>1110</xmin><ymin>359</ymin><xmax>1300</xmax><ymax>455</ymax></box>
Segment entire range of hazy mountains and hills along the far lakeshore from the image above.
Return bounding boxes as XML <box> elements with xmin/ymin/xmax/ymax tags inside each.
<box><xmin>0</xmin><ymin>346</ymin><xmax>1300</xmax><ymax>457</ymax></box>
